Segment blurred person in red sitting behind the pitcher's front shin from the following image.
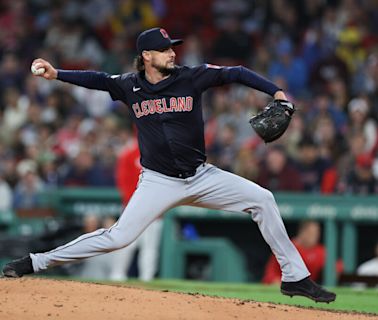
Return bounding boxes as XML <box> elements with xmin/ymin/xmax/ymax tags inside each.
<box><xmin>262</xmin><ymin>221</ymin><xmax>326</xmax><ymax>284</ymax></box>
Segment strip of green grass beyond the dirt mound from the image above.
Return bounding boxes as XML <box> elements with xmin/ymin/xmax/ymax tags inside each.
<box><xmin>39</xmin><ymin>277</ymin><xmax>378</xmax><ymax>315</ymax></box>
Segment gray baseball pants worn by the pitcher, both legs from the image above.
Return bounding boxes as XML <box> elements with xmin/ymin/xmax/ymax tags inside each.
<box><xmin>30</xmin><ymin>164</ymin><xmax>310</xmax><ymax>282</ymax></box>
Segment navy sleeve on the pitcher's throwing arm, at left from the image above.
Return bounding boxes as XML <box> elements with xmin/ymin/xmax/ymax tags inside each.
<box><xmin>57</xmin><ymin>70</ymin><xmax>129</xmax><ymax>101</ymax></box>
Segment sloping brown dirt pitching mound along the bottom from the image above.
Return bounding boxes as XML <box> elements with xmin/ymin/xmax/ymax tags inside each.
<box><xmin>0</xmin><ymin>278</ymin><xmax>376</xmax><ymax>320</ymax></box>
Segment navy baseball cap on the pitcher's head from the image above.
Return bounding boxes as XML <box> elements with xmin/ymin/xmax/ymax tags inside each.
<box><xmin>137</xmin><ymin>28</ymin><xmax>184</xmax><ymax>54</ymax></box>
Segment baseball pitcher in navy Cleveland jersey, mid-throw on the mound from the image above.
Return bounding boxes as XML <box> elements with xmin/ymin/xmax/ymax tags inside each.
<box><xmin>3</xmin><ymin>28</ymin><xmax>336</xmax><ymax>303</ymax></box>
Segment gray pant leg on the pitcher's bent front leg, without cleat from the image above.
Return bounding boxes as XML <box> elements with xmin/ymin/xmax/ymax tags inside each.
<box><xmin>190</xmin><ymin>166</ymin><xmax>310</xmax><ymax>282</ymax></box>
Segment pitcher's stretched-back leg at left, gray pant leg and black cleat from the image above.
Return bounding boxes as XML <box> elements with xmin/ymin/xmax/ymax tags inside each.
<box><xmin>3</xmin><ymin>169</ymin><xmax>186</xmax><ymax>277</ymax></box>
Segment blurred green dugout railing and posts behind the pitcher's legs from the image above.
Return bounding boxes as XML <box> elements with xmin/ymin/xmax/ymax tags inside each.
<box><xmin>11</xmin><ymin>188</ymin><xmax>378</xmax><ymax>286</ymax></box>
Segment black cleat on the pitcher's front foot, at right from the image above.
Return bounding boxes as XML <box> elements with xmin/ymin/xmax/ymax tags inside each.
<box><xmin>281</xmin><ymin>277</ymin><xmax>336</xmax><ymax>303</ymax></box>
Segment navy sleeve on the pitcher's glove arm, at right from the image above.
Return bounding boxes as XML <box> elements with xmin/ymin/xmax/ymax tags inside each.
<box><xmin>191</xmin><ymin>64</ymin><xmax>280</xmax><ymax>96</ymax></box>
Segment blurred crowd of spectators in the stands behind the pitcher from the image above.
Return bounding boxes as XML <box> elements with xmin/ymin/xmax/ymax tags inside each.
<box><xmin>0</xmin><ymin>0</ymin><xmax>378</xmax><ymax>209</ymax></box>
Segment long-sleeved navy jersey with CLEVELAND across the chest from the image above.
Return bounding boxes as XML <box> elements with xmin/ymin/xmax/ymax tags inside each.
<box><xmin>58</xmin><ymin>64</ymin><xmax>279</xmax><ymax>176</ymax></box>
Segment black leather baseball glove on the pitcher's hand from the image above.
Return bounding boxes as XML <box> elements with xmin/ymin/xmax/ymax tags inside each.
<box><xmin>249</xmin><ymin>99</ymin><xmax>295</xmax><ymax>143</ymax></box>
